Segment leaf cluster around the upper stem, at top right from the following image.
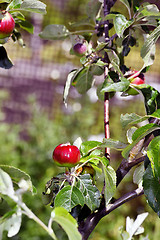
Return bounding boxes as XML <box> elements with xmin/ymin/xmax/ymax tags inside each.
<box><xmin>40</xmin><ymin>0</ymin><xmax>160</xmax><ymax>103</ymax></box>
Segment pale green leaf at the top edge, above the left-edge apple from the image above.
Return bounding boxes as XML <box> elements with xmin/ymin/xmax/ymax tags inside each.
<box><xmin>20</xmin><ymin>0</ymin><xmax>46</xmax><ymax>14</ymax></box>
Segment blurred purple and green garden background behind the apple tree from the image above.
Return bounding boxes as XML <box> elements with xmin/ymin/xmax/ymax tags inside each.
<box><xmin>0</xmin><ymin>0</ymin><xmax>160</xmax><ymax>240</ymax></box>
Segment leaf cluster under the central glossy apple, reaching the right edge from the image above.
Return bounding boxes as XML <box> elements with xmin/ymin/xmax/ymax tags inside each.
<box><xmin>43</xmin><ymin>97</ymin><xmax>160</xmax><ymax>217</ymax></box>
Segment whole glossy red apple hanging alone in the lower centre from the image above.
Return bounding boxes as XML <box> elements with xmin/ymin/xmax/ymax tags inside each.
<box><xmin>53</xmin><ymin>143</ymin><xmax>80</xmax><ymax>167</ymax></box>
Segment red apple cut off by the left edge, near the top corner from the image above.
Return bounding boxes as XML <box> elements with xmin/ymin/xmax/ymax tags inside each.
<box><xmin>0</xmin><ymin>11</ymin><xmax>15</xmax><ymax>39</ymax></box>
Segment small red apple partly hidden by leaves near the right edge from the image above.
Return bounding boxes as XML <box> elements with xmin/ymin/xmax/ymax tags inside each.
<box><xmin>126</xmin><ymin>71</ymin><xmax>145</xmax><ymax>95</ymax></box>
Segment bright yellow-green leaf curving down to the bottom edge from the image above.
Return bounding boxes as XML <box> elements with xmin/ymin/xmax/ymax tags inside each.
<box><xmin>51</xmin><ymin>207</ymin><xmax>82</xmax><ymax>240</ymax></box>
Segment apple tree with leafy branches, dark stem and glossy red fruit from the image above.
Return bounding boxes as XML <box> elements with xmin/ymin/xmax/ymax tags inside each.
<box><xmin>0</xmin><ymin>0</ymin><xmax>160</xmax><ymax>240</ymax></box>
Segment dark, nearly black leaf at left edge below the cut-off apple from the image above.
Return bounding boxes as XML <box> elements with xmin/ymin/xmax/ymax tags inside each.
<box><xmin>0</xmin><ymin>46</ymin><xmax>13</xmax><ymax>69</ymax></box>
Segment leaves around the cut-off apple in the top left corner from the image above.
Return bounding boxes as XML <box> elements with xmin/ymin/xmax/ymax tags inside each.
<box><xmin>0</xmin><ymin>0</ymin><xmax>46</xmax><ymax>69</ymax></box>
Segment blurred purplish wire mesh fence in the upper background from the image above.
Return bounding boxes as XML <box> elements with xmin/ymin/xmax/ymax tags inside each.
<box><xmin>0</xmin><ymin>0</ymin><xmax>160</xmax><ymax>122</ymax></box>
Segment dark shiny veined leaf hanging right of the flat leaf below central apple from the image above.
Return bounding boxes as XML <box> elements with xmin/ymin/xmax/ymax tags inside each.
<box><xmin>77</xmin><ymin>174</ymin><xmax>100</xmax><ymax>211</ymax></box>
